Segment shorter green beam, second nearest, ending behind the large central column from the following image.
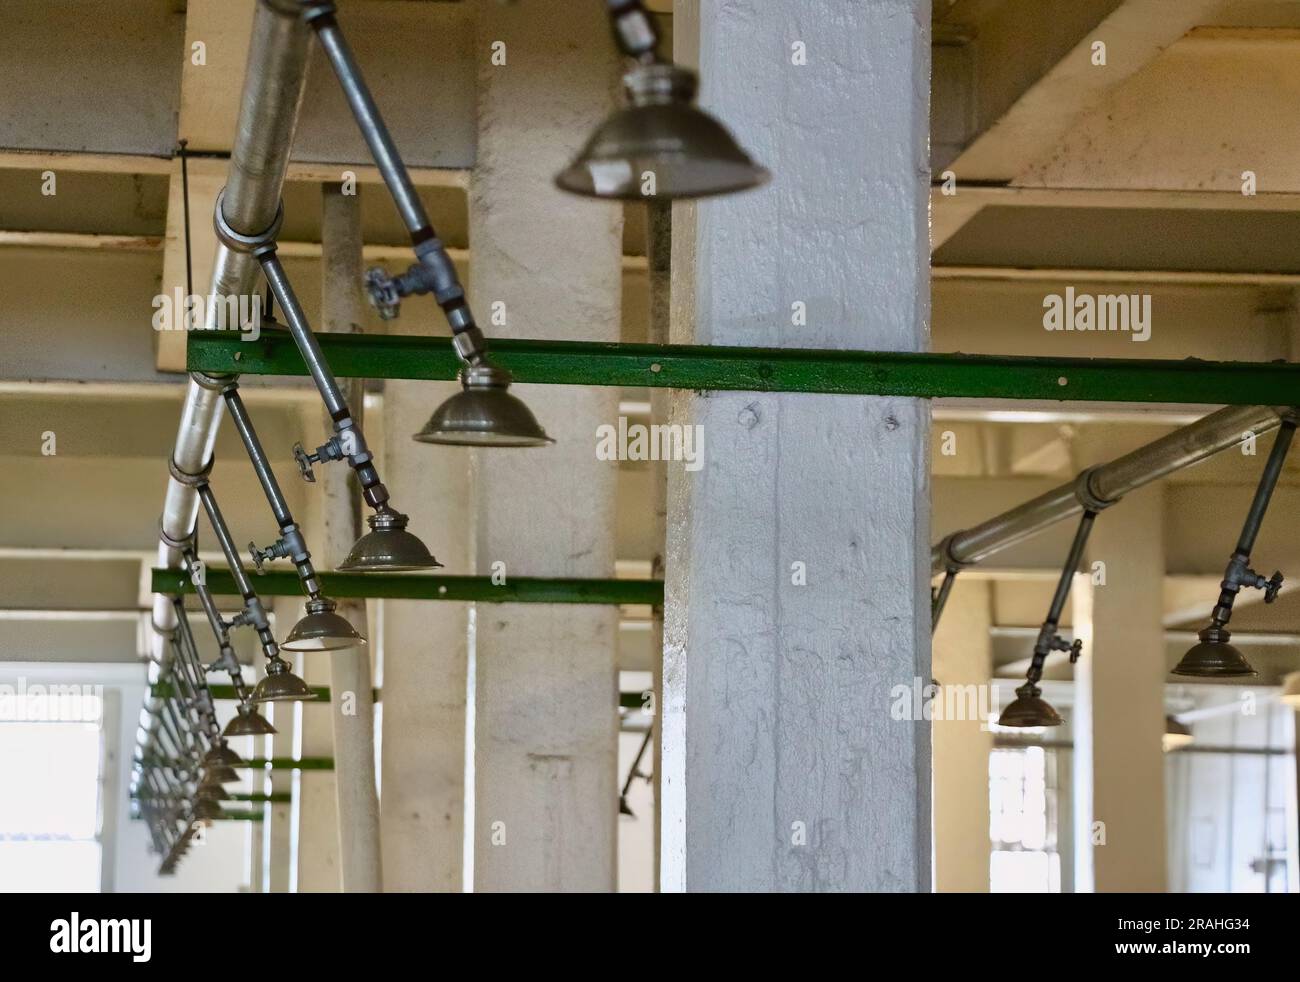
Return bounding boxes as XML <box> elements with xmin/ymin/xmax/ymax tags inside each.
<box><xmin>151</xmin><ymin>568</ymin><xmax>663</xmax><ymax>605</ymax></box>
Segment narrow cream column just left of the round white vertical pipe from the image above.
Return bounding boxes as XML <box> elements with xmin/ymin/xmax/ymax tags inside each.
<box><xmin>286</xmin><ymin>597</ymin><xmax>342</xmax><ymax>894</ymax></box>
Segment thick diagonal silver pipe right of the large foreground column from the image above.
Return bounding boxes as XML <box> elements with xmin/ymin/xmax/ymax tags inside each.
<box><xmin>930</xmin><ymin>406</ymin><xmax>1292</xmax><ymax>575</ymax></box>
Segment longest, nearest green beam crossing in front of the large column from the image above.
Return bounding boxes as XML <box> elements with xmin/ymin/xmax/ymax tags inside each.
<box><xmin>187</xmin><ymin>329</ymin><xmax>1300</xmax><ymax>406</ymax></box>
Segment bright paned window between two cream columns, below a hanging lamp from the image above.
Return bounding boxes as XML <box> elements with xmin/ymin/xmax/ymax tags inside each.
<box><xmin>988</xmin><ymin>747</ymin><xmax>1061</xmax><ymax>894</ymax></box>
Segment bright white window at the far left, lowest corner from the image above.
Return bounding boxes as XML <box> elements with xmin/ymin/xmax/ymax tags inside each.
<box><xmin>0</xmin><ymin>685</ymin><xmax>103</xmax><ymax>892</ymax></box>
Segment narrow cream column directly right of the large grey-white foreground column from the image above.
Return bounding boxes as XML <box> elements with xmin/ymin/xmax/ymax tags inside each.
<box><xmin>931</xmin><ymin>576</ymin><xmax>993</xmax><ymax>894</ymax></box>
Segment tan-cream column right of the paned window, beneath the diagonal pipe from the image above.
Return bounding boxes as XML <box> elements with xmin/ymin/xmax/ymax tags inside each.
<box><xmin>1073</xmin><ymin>485</ymin><xmax>1169</xmax><ymax>892</ymax></box>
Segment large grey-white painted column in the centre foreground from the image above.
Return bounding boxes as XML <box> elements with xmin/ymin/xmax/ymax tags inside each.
<box><xmin>659</xmin><ymin>0</ymin><xmax>931</xmax><ymax>891</ymax></box>
